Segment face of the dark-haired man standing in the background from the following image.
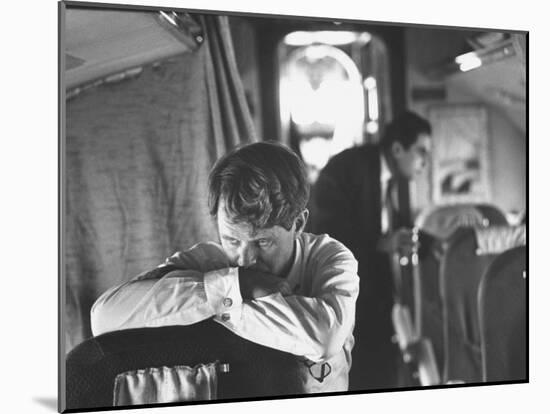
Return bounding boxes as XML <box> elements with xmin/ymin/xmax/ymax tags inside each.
<box><xmin>392</xmin><ymin>134</ymin><xmax>431</xmax><ymax>180</ymax></box>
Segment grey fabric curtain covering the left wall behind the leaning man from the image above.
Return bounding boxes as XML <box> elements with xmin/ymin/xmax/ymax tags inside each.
<box><xmin>62</xmin><ymin>15</ymin><xmax>257</xmax><ymax>352</ymax></box>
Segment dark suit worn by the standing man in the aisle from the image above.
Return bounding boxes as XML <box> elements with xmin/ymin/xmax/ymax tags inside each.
<box><xmin>311</xmin><ymin>145</ymin><xmax>424</xmax><ymax>390</ymax></box>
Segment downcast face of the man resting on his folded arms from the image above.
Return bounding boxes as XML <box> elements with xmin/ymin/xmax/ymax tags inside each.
<box><xmin>217</xmin><ymin>202</ymin><xmax>301</xmax><ymax>277</ymax></box>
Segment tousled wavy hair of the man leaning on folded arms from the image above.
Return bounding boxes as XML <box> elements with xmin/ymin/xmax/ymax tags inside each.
<box><xmin>208</xmin><ymin>141</ymin><xmax>309</xmax><ymax>230</ymax></box>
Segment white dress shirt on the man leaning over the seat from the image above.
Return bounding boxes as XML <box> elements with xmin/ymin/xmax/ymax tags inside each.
<box><xmin>91</xmin><ymin>233</ymin><xmax>359</xmax><ymax>393</ymax></box>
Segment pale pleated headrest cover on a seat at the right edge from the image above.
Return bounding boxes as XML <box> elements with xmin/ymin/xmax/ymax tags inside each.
<box><xmin>474</xmin><ymin>225</ymin><xmax>527</xmax><ymax>256</ymax></box>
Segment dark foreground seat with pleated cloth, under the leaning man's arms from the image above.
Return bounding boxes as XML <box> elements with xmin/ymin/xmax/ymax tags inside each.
<box><xmin>66</xmin><ymin>320</ymin><xmax>301</xmax><ymax>409</ymax></box>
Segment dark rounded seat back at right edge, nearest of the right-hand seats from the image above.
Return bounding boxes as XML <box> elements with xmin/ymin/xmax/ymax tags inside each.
<box><xmin>478</xmin><ymin>246</ymin><xmax>527</xmax><ymax>382</ymax></box>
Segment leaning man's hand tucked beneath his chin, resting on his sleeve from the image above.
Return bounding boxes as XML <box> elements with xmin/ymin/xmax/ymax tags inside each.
<box><xmin>239</xmin><ymin>267</ymin><xmax>292</xmax><ymax>300</ymax></box>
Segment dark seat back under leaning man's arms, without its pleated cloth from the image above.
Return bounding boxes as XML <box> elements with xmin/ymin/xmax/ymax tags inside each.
<box><xmin>66</xmin><ymin>320</ymin><xmax>301</xmax><ymax>409</ymax></box>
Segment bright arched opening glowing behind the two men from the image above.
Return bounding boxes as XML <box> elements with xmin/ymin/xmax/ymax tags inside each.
<box><xmin>280</xmin><ymin>45</ymin><xmax>365</xmax><ymax>174</ymax></box>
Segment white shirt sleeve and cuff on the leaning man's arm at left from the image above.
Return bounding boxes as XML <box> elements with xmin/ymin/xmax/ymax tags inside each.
<box><xmin>91</xmin><ymin>245</ymin><xmax>242</xmax><ymax>335</ymax></box>
